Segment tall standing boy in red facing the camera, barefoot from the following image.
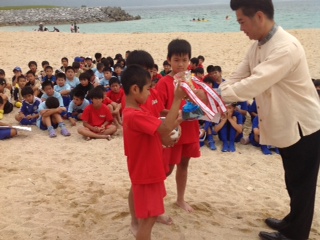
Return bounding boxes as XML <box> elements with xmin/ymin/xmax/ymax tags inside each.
<box><xmin>156</xmin><ymin>39</ymin><xmax>200</xmax><ymax>212</ymax></box>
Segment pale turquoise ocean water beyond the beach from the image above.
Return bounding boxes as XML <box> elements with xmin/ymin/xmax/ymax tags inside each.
<box><xmin>0</xmin><ymin>0</ymin><xmax>320</xmax><ymax>33</ymax></box>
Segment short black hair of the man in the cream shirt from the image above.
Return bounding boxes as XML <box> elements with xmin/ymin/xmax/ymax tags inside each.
<box><xmin>230</xmin><ymin>0</ymin><xmax>274</xmax><ymax>20</ymax></box>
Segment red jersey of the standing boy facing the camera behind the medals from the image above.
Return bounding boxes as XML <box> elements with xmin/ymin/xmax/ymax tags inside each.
<box><xmin>156</xmin><ymin>75</ymin><xmax>199</xmax><ymax>144</ymax></box>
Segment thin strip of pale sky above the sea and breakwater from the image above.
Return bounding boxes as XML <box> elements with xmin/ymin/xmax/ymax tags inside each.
<box><xmin>0</xmin><ymin>0</ymin><xmax>229</xmax><ymax>7</ymax></box>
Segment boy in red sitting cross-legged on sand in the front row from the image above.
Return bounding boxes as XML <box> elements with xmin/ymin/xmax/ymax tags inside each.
<box><xmin>78</xmin><ymin>87</ymin><xmax>117</xmax><ymax>140</ymax></box>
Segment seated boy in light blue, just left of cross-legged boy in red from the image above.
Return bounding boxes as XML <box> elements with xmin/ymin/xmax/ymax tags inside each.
<box><xmin>68</xmin><ymin>90</ymin><xmax>90</xmax><ymax>126</ymax></box>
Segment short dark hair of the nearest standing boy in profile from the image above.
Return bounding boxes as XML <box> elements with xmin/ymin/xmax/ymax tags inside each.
<box><xmin>122</xmin><ymin>64</ymin><xmax>151</xmax><ymax>95</ymax></box>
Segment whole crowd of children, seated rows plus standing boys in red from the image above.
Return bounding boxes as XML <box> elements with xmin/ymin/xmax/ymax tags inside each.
<box><xmin>0</xmin><ymin>45</ymin><xmax>320</xmax><ymax>239</ymax></box>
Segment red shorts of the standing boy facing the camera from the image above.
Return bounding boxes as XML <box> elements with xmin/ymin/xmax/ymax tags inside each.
<box><xmin>163</xmin><ymin>142</ymin><xmax>200</xmax><ymax>165</ymax></box>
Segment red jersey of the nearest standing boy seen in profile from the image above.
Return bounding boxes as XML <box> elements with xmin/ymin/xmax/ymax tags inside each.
<box><xmin>123</xmin><ymin>108</ymin><xmax>166</xmax><ymax>184</ymax></box>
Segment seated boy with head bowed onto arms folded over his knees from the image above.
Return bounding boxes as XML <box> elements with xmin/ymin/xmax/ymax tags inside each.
<box><xmin>36</xmin><ymin>97</ymin><xmax>71</xmax><ymax>138</ymax></box>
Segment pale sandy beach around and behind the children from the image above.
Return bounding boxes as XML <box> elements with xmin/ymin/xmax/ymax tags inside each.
<box><xmin>0</xmin><ymin>30</ymin><xmax>320</xmax><ymax>240</ymax></box>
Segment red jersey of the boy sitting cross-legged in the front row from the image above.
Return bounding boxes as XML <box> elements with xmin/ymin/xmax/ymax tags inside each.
<box><xmin>82</xmin><ymin>104</ymin><xmax>113</xmax><ymax>127</ymax></box>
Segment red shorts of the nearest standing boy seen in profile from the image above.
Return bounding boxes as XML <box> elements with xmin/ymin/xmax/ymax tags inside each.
<box><xmin>132</xmin><ymin>182</ymin><xmax>167</xmax><ymax>219</ymax></box>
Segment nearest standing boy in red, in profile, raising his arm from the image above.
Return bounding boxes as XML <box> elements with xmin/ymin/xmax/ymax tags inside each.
<box><xmin>122</xmin><ymin>65</ymin><xmax>185</xmax><ymax>240</ymax></box>
